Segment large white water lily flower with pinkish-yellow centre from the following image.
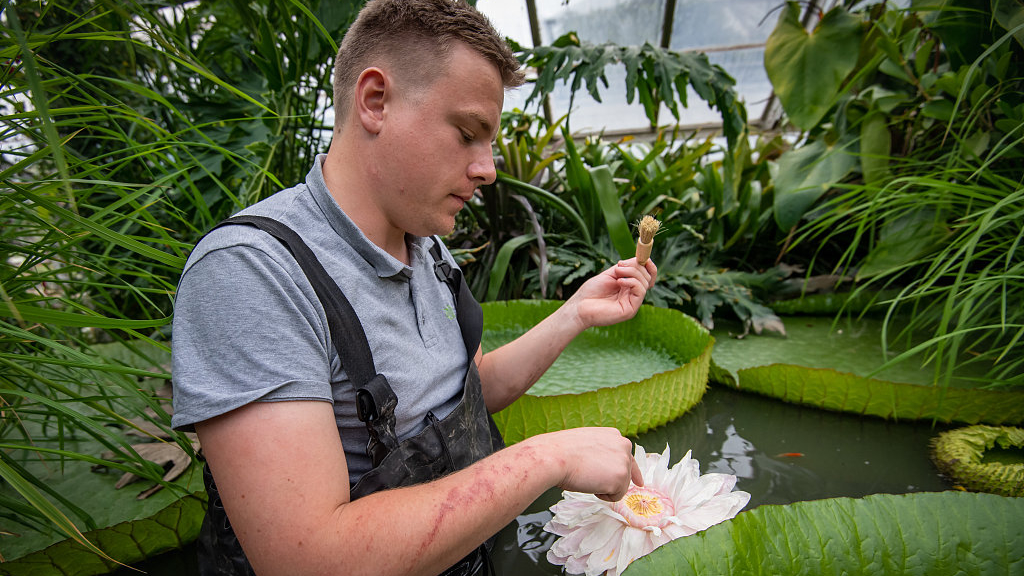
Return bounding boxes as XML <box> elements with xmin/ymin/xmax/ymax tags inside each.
<box><xmin>544</xmin><ymin>445</ymin><xmax>751</xmax><ymax>576</ymax></box>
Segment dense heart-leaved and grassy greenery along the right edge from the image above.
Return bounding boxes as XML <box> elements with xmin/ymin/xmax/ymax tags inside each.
<box><xmin>765</xmin><ymin>0</ymin><xmax>1024</xmax><ymax>385</ymax></box>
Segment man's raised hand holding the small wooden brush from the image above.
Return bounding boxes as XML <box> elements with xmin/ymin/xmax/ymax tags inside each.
<box><xmin>565</xmin><ymin>258</ymin><xmax>657</xmax><ymax>331</ymax></box>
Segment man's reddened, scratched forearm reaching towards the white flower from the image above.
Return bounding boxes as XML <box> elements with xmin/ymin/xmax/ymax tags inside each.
<box><xmin>239</xmin><ymin>430</ymin><xmax>564</xmax><ymax>576</ymax></box>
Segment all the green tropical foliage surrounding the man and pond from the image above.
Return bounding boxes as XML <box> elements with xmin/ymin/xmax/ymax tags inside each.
<box><xmin>0</xmin><ymin>0</ymin><xmax>1024</xmax><ymax>565</ymax></box>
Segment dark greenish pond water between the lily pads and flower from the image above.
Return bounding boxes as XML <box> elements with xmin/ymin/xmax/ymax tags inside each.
<box><xmin>117</xmin><ymin>386</ymin><xmax>951</xmax><ymax>576</ymax></box>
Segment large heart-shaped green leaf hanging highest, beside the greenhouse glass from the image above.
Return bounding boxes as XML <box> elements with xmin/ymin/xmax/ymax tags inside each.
<box><xmin>765</xmin><ymin>2</ymin><xmax>861</xmax><ymax>130</ymax></box>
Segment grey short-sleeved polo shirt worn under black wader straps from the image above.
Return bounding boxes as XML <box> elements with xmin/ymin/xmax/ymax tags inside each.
<box><xmin>172</xmin><ymin>156</ymin><xmax>468</xmax><ymax>482</ymax></box>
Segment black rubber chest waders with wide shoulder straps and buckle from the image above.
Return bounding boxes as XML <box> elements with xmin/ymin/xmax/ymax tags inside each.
<box><xmin>198</xmin><ymin>216</ymin><xmax>504</xmax><ymax>576</ymax></box>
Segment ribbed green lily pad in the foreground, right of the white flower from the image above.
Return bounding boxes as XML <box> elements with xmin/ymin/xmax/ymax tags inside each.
<box><xmin>626</xmin><ymin>492</ymin><xmax>1024</xmax><ymax>576</ymax></box>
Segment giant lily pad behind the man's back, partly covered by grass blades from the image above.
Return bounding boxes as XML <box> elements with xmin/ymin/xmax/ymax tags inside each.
<box><xmin>0</xmin><ymin>342</ymin><xmax>206</xmax><ymax>576</ymax></box>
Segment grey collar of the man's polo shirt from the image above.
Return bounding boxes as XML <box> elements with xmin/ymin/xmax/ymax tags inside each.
<box><xmin>306</xmin><ymin>154</ymin><xmax>429</xmax><ymax>279</ymax></box>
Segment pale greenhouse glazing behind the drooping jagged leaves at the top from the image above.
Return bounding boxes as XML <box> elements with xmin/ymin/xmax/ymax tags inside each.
<box><xmin>477</xmin><ymin>0</ymin><xmax>780</xmax><ymax>131</ymax></box>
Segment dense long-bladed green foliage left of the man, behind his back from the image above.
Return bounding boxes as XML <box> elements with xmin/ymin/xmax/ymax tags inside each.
<box><xmin>0</xmin><ymin>0</ymin><xmax>356</xmax><ymax>557</ymax></box>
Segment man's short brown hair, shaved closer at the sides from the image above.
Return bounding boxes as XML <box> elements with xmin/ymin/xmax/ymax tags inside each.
<box><xmin>334</xmin><ymin>0</ymin><xmax>524</xmax><ymax>127</ymax></box>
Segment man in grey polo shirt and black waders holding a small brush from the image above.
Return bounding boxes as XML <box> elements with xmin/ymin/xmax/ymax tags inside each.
<box><xmin>173</xmin><ymin>0</ymin><xmax>656</xmax><ymax>576</ymax></box>
